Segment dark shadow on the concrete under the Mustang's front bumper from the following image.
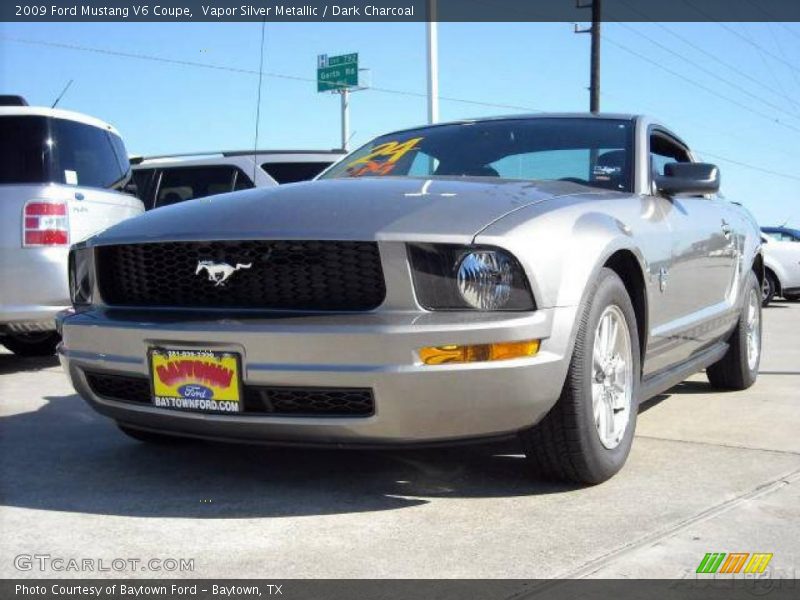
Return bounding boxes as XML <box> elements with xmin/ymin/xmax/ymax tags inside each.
<box><xmin>0</xmin><ymin>394</ymin><xmax>579</xmax><ymax>518</ymax></box>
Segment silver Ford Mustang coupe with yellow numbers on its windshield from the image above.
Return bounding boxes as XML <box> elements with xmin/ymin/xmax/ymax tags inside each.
<box><xmin>58</xmin><ymin>114</ymin><xmax>763</xmax><ymax>483</ymax></box>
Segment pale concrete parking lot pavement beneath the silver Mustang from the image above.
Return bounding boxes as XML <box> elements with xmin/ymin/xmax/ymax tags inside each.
<box><xmin>0</xmin><ymin>301</ymin><xmax>800</xmax><ymax>578</ymax></box>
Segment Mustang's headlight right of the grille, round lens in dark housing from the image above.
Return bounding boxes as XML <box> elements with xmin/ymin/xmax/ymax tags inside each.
<box><xmin>409</xmin><ymin>244</ymin><xmax>535</xmax><ymax>311</ymax></box>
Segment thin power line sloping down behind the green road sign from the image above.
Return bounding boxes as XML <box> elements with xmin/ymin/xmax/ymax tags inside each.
<box><xmin>0</xmin><ymin>36</ymin><xmax>542</xmax><ymax>112</ymax></box>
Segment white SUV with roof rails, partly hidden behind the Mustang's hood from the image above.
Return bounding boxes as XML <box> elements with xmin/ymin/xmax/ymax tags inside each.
<box><xmin>130</xmin><ymin>150</ymin><xmax>345</xmax><ymax>210</ymax></box>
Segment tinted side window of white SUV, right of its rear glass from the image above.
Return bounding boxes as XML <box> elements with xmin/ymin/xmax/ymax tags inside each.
<box><xmin>52</xmin><ymin>119</ymin><xmax>128</xmax><ymax>188</ymax></box>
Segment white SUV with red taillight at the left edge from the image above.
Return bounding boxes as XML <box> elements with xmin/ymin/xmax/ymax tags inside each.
<box><xmin>0</xmin><ymin>97</ymin><xmax>144</xmax><ymax>356</ymax></box>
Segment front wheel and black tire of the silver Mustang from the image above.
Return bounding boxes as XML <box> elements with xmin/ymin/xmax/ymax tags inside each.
<box><xmin>520</xmin><ymin>268</ymin><xmax>641</xmax><ymax>484</ymax></box>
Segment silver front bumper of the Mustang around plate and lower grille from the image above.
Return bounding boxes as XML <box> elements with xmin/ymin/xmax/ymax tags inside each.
<box><xmin>59</xmin><ymin>307</ymin><xmax>576</xmax><ymax>444</ymax></box>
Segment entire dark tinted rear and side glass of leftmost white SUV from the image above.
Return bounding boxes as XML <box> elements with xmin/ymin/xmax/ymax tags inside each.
<box><xmin>0</xmin><ymin>115</ymin><xmax>130</xmax><ymax>188</ymax></box>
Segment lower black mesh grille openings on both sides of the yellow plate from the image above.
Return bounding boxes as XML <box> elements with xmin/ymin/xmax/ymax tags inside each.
<box><xmin>84</xmin><ymin>371</ymin><xmax>375</xmax><ymax>417</ymax></box>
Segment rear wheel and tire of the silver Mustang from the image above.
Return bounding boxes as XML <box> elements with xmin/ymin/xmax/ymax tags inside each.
<box><xmin>706</xmin><ymin>272</ymin><xmax>761</xmax><ymax>390</ymax></box>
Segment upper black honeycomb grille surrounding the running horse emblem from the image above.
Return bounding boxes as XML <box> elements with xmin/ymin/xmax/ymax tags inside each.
<box><xmin>96</xmin><ymin>241</ymin><xmax>386</xmax><ymax>311</ymax></box>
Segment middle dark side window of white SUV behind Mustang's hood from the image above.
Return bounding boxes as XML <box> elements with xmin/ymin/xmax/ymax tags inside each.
<box><xmin>155</xmin><ymin>166</ymin><xmax>237</xmax><ymax>207</ymax></box>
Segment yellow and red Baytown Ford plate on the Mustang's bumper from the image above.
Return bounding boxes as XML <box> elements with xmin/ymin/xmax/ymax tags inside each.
<box><xmin>149</xmin><ymin>348</ymin><xmax>242</xmax><ymax>413</ymax></box>
